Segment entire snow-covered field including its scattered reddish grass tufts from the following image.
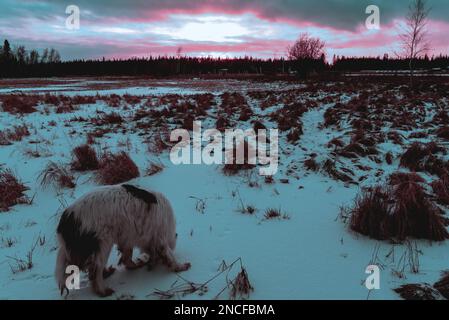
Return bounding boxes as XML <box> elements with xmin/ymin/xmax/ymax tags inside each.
<box><xmin>0</xmin><ymin>79</ymin><xmax>449</xmax><ymax>299</ymax></box>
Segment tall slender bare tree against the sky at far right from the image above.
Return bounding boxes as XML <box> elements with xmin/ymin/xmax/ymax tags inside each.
<box><xmin>401</xmin><ymin>0</ymin><xmax>430</xmax><ymax>86</ymax></box>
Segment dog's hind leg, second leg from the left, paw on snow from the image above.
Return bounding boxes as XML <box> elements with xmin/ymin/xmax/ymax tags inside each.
<box><xmin>89</xmin><ymin>243</ymin><xmax>114</xmax><ymax>297</ymax></box>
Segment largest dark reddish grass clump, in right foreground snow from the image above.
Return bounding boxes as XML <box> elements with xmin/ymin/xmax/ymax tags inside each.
<box><xmin>350</xmin><ymin>174</ymin><xmax>449</xmax><ymax>241</ymax></box>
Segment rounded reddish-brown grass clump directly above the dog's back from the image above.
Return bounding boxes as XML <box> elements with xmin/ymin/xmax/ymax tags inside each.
<box><xmin>97</xmin><ymin>151</ymin><xmax>140</xmax><ymax>184</ymax></box>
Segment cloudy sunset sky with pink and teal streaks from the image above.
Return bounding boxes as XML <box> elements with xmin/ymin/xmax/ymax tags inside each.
<box><xmin>0</xmin><ymin>0</ymin><xmax>449</xmax><ymax>60</ymax></box>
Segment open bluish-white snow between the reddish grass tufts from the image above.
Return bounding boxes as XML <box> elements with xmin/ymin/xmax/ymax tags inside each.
<box><xmin>0</xmin><ymin>80</ymin><xmax>449</xmax><ymax>299</ymax></box>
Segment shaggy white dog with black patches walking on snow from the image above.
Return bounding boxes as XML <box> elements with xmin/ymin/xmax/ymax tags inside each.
<box><xmin>56</xmin><ymin>184</ymin><xmax>190</xmax><ymax>296</ymax></box>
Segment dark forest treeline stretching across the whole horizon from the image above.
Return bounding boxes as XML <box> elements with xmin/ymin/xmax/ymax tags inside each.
<box><xmin>0</xmin><ymin>40</ymin><xmax>449</xmax><ymax>78</ymax></box>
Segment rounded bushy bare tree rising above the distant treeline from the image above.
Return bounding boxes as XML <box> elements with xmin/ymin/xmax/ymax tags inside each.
<box><xmin>287</xmin><ymin>33</ymin><xmax>325</xmax><ymax>60</ymax></box>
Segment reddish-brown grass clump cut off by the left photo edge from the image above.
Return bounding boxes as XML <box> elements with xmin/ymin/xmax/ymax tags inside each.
<box><xmin>0</xmin><ymin>169</ymin><xmax>29</xmax><ymax>212</ymax></box>
